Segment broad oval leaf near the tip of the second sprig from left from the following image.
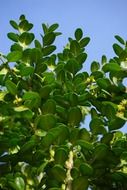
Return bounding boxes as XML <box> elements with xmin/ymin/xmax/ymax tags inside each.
<box><xmin>43</xmin><ymin>32</ymin><xmax>56</xmax><ymax>46</ymax></box>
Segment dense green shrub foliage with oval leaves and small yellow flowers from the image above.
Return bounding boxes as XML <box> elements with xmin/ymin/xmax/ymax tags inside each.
<box><xmin>0</xmin><ymin>15</ymin><xmax>127</xmax><ymax>190</ymax></box>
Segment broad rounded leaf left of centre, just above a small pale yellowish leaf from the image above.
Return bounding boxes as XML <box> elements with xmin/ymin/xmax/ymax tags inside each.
<box><xmin>37</xmin><ymin>114</ymin><xmax>56</xmax><ymax>131</ymax></box>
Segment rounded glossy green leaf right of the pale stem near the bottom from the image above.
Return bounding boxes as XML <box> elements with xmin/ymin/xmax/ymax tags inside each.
<box><xmin>79</xmin><ymin>163</ymin><xmax>93</xmax><ymax>176</ymax></box>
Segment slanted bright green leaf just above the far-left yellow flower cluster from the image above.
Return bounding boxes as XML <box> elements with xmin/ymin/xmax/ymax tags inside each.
<box><xmin>5</xmin><ymin>80</ymin><xmax>17</xmax><ymax>95</ymax></box>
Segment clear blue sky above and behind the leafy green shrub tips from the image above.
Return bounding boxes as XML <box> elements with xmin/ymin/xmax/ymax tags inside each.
<box><xmin>0</xmin><ymin>0</ymin><xmax>127</xmax><ymax>131</ymax></box>
